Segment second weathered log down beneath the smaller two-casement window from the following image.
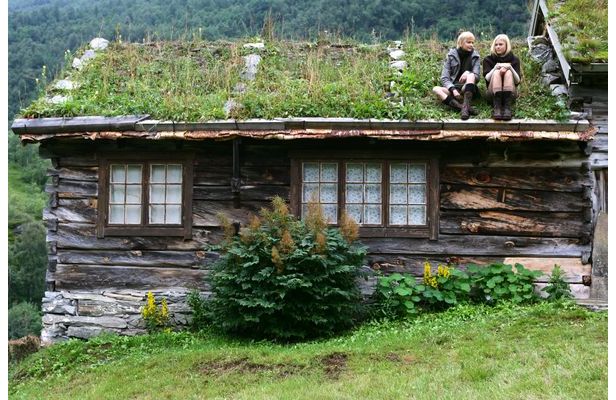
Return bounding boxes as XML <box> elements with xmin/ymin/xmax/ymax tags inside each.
<box><xmin>58</xmin><ymin>249</ymin><xmax>218</xmax><ymax>268</ymax></box>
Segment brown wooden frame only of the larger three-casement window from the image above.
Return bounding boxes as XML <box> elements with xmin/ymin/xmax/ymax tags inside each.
<box><xmin>290</xmin><ymin>151</ymin><xmax>439</xmax><ymax>240</ymax></box>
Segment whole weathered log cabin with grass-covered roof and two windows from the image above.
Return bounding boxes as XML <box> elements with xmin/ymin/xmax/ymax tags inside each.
<box><xmin>12</xmin><ymin>1</ymin><xmax>607</xmax><ymax>343</ymax></box>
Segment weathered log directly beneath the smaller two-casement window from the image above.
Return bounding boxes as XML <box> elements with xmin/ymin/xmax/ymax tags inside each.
<box><xmin>47</xmin><ymin>223</ymin><xmax>222</xmax><ymax>251</ymax></box>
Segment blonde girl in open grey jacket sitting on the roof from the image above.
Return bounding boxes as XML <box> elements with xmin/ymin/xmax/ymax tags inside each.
<box><xmin>432</xmin><ymin>32</ymin><xmax>479</xmax><ymax>119</ymax></box>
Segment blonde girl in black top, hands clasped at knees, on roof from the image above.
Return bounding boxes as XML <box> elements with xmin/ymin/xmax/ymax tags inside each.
<box><xmin>483</xmin><ymin>34</ymin><xmax>522</xmax><ymax>121</ymax></box>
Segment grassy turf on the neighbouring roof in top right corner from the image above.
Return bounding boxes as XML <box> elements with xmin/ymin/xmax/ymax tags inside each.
<box><xmin>546</xmin><ymin>0</ymin><xmax>608</xmax><ymax>64</ymax></box>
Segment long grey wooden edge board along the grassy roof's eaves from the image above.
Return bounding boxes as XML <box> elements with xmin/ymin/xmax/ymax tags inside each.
<box><xmin>11</xmin><ymin>116</ymin><xmax>590</xmax><ymax>136</ymax></box>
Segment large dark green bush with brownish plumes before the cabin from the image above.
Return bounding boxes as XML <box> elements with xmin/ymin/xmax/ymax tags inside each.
<box><xmin>208</xmin><ymin>198</ymin><xmax>366</xmax><ymax>340</ymax></box>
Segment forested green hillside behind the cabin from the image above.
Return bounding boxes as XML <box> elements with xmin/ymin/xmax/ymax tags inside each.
<box><xmin>8</xmin><ymin>0</ymin><xmax>532</xmax><ymax>338</ymax></box>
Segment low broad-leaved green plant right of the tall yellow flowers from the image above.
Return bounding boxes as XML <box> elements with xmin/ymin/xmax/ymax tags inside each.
<box><xmin>467</xmin><ymin>263</ymin><xmax>542</xmax><ymax>304</ymax></box>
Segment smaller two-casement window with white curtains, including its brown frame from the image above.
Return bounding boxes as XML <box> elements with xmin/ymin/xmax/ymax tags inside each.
<box><xmin>98</xmin><ymin>155</ymin><xmax>192</xmax><ymax>238</ymax></box>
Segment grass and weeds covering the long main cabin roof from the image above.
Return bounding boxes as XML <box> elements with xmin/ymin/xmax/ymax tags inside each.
<box><xmin>21</xmin><ymin>38</ymin><xmax>568</xmax><ymax>122</ymax></box>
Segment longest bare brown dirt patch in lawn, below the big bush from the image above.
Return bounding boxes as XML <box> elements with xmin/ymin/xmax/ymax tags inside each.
<box><xmin>196</xmin><ymin>358</ymin><xmax>305</xmax><ymax>377</ymax></box>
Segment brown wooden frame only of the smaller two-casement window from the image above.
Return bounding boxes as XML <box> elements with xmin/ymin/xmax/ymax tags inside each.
<box><xmin>96</xmin><ymin>153</ymin><xmax>194</xmax><ymax>239</ymax></box>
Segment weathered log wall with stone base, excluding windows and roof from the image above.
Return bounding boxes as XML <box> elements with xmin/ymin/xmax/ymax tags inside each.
<box><xmin>41</xmin><ymin>139</ymin><xmax>594</xmax><ymax>341</ymax></box>
